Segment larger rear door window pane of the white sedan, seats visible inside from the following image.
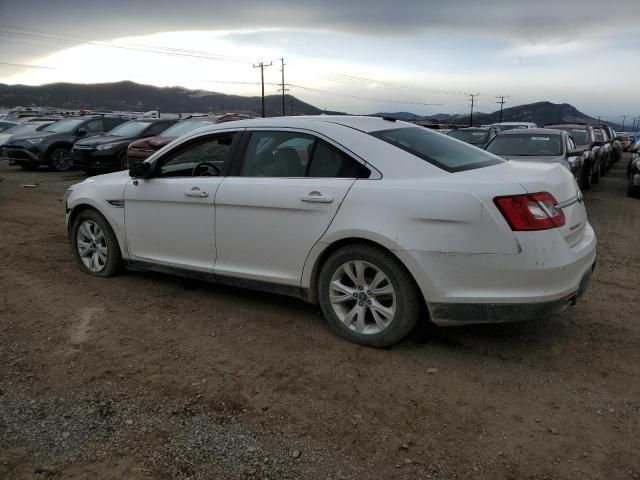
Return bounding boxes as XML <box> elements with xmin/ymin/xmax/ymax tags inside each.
<box><xmin>240</xmin><ymin>132</ymin><xmax>315</xmax><ymax>177</ymax></box>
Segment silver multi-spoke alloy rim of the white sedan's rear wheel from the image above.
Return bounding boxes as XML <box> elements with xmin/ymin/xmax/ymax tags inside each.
<box><xmin>329</xmin><ymin>260</ymin><xmax>396</xmax><ymax>335</ymax></box>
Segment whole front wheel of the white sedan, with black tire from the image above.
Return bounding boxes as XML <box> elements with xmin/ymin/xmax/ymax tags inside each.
<box><xmin>71</xmin><ymin>209</ymin><xmax>122</xmax><ymax>277</ymax></box>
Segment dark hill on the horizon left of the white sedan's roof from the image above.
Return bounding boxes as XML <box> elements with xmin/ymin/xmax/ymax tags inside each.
<box><xmin>0</xmin><ymin>81</ymin><xmax>333</xmax><ymax>116</ymax></box>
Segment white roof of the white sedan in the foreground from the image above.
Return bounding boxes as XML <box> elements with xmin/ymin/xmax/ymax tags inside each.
<box><xmin>191</xmin><ymin>115</ymin><xmax>410</xmax><ymax>133</ymax></box>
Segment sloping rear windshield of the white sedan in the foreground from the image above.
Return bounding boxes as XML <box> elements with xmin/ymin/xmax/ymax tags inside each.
<box><xmin>371</xmin><ymin>127</ymin><xmax>503</xmax><ymax>172</ymax></box>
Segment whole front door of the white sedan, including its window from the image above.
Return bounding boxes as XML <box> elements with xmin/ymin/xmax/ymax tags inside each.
<box><xmin>124</xmin><ymin>131</ymin><xmax>239</xmax><ymax>274</ymax></box>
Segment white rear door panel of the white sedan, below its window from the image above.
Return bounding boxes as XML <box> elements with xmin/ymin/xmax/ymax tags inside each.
<box><xmin>215</xmin><ymin>177</ymin><xmax>355</xmax><ymax>286</ymax></box>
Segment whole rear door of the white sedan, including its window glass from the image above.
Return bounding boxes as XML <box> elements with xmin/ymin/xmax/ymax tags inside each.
<box><xmin>215</xmin><ymin>129</ymin><xmax>369</xmax><ymax>287</ymax></box>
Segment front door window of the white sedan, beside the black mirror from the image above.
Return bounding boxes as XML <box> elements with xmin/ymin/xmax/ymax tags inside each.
<box><xmin>158</xmin><ymin>133</ymin><xmax>236</xmax><ymax>177</ymax></box>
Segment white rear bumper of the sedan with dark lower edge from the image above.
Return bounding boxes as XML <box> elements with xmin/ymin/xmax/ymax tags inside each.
<box><xmin>396</xmin><ymin>224</ymin><xmax>596</xmax><ymax>325</ymax></box>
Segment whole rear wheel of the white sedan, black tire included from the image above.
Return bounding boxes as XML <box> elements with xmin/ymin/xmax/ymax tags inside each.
<box><xmin>318</xmin><ymin>244</ymin><xmax>423</xmax><ymax>347</ymax></box>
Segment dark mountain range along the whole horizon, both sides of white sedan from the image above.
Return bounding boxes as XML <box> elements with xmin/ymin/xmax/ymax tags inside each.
<box><xmin>0</xmin><ymin>81</ymin><xmax>621</xmax><ymax>130</ymax></box>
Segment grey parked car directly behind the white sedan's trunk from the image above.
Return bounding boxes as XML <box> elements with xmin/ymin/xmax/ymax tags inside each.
<box><xmin>486</xmin><ymin>128</ymin><xmax>584</xmax><ymax>186</ymax></box>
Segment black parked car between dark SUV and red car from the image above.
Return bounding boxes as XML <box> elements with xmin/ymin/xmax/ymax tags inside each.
<box><xmin>72</xmin><ymin>119</ymin><xmax>176</xmax><ymax>174</ymax></box>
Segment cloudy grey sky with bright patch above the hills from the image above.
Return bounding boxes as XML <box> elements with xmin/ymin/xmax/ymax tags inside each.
<box><xmin>0</xmin><ymin>0</ymin><xmax>640</xmax><ymax>122</ymax></box>
